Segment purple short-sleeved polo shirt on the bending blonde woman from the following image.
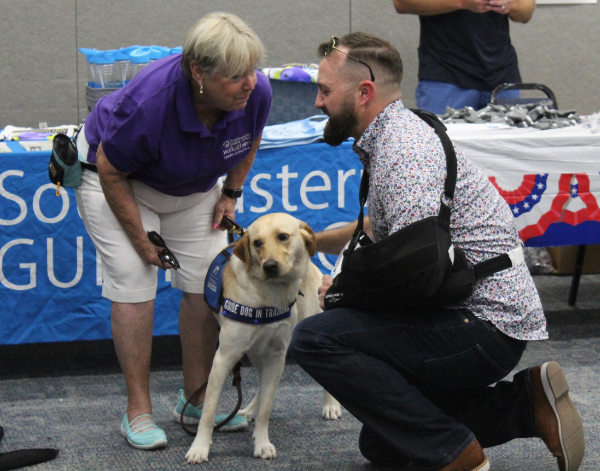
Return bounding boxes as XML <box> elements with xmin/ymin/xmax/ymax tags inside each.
<box><xmin>84</xmin><ymin>54</ymin><xmax>271</xmax><ymax>196</ymax></box>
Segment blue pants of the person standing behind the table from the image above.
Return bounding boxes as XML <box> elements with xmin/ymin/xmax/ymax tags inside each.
<box><xmin>416</xmin><ymin>80</ymin><xmax>521</xmax><ymax>114</ymax></box>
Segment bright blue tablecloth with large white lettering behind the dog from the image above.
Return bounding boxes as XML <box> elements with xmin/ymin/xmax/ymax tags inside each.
<box><xmin>0</xmin><ymin>142</ymin><xmax>362</xmax><ymax>344</ymax></box>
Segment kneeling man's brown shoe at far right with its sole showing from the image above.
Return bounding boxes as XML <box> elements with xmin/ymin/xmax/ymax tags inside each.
<box><xmin>529</xmin><ymin>361</ymin><xmax>585</xmax><ymax>471</ymax></box>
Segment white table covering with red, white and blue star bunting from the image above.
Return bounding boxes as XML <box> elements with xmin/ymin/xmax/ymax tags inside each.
<box><xmin>448</xmin><ymin>125</ymin><xmax>600</xmax><ymax>247</ymax></box>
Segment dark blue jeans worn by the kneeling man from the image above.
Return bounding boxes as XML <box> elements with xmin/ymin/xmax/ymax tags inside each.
<box><xmin>290</xmin><ymin>308</ymin><xmax>537</xmax><ymax>470</ymax></box>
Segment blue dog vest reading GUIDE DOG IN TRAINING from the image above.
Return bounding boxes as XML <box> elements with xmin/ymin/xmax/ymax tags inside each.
<box><xmin>204</xmin><ymin>244</ymin><xmax>295</xmax><ymax>325</ymax></box>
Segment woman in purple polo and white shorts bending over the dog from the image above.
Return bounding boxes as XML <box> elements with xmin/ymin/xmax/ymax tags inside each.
<box><xmin>76</xmin><ymin>13</ymin><xmax>271</xmax><ymax>449</ymax></box>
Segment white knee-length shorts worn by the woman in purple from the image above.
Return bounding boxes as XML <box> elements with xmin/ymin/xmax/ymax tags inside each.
<box><xmin>75</xmin><ymin>160</ymin><xmax>227</xmax><ymax>303</ymax></box>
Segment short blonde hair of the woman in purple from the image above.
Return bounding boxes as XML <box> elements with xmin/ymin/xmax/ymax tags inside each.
<box><xmin>181</xmin><ymin>12</ymin><xmax>265</xmax><ymax>79</ymax></box>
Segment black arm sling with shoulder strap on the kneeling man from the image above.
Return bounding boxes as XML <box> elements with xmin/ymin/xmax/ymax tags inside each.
<box><xmin>325</xmin><ymin>110</ymin><xmax>522</xmax><ymax>312</ymax></box>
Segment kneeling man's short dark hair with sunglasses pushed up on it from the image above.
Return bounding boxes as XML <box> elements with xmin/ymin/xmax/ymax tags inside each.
<box><xmin>318</xmin><ymin>32</ymin><xmax>403</xmax><ymax>84</ymax></box>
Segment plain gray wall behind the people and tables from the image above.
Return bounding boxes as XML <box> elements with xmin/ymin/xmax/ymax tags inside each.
<box><xmin>0</xmin><ymin>0</ymin><xmax>600</xmax><ymax>127</ymax></box>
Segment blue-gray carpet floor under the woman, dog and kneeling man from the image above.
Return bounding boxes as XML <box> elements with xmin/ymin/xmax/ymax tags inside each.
<box><xmin>0</xmin><ymin>275</ymin><xmax>600</xmax><ymax>471</ymax></box>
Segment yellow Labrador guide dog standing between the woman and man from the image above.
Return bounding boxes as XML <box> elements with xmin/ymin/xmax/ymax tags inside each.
<box><xmin>185</xmin><ymin>213</ymin><xmax>341</xmax><ymax>463</ymax></box>
